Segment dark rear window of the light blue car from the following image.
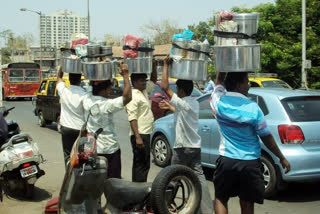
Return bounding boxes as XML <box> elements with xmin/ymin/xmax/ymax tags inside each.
<box><xmin>281</xmin><ymin>96</ymin><xmax>320</xmax><ymax>122</ymax></box>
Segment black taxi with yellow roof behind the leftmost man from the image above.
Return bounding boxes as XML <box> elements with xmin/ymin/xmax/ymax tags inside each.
<box><xmin>33</xmin><ymin>77</ymin><xmax>89</xmax><ymax>132</ymax></box>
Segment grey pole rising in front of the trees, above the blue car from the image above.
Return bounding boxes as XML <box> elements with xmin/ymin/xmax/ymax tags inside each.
<box><xmin>301</xmin><ymin>0</ymin><xmax>308</xmax><ymax>89</ymax></box>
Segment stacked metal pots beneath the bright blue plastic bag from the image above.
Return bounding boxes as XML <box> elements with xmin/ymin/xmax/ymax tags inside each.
<box><xmin>169</xmin><ymin>38</ymin><xmax>210</xmax><ymax>80</ymax></box>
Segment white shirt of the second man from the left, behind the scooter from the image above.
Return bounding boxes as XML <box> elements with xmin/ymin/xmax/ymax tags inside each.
<box><xmin>83</xmin><ymin>92</ymin><xmax>124</xmax><ymax>154</ymax></box>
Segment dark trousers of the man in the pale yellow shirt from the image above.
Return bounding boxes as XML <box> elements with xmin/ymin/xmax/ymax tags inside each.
<box><xmin>130</xmin><ymin>134</ymin><xmax>150</xmax><ymax>182</ymax></box>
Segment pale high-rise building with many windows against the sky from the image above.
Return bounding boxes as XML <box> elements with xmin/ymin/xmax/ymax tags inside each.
<box><xmin>40</xmin><ymin>10</ymin><xmax>89</xmax><ymax>47</ymax></box>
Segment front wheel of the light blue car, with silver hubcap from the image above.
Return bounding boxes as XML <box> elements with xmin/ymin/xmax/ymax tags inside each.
<box><xmin>152</xmin><ymin>135</ymin><xmax>172</xmax><ymax>167</ymax></box>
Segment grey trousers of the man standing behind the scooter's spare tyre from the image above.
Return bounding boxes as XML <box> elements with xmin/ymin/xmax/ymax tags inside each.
<box><xmin>171</xmin><ymin>148</ymin><xmax>213</xmax><ymax>214</ymax></box>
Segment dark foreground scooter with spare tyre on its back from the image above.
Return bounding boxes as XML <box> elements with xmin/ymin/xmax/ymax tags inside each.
<box><xmin>45</xmin><ymin>105</ymin><xmax>201</xmax><ymax>214</ymax></box>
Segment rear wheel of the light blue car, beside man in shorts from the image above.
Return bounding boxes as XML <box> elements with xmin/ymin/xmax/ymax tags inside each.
<box><xmin>261</xmin><ymin>156</ymin><xmax>278</xmax><ymax>198</ymax></box>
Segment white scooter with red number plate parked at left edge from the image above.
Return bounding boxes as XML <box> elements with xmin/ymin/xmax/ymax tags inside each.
<box><xmin>0</xmin><ymin>107</ymin><xmax>45</xmax><ymax>201</ymax></box>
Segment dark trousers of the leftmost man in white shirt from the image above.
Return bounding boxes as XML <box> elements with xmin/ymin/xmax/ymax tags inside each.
<box><xmin>61</xmin><ymin>126</ymin><xmax>80</xmax><ymax>166</ymax></box>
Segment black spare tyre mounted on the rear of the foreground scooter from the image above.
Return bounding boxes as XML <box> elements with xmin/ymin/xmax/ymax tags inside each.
<box><xmin>150</xmin><ymin>165</ymin><xmax>202</xmax><ymax>214</ymax></box>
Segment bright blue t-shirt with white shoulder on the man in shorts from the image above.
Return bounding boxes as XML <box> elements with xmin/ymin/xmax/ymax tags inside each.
<box><xmin>210</xmin><ymin>85</ymin><xmax>270</xmax><ymax>160</ymax></box>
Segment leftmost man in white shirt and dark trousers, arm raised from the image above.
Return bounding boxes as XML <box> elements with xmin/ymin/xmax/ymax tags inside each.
<box><xmin>57</xmin><ymin>67</ymin><xmax>86</xmax><ymax>165</ymax></box>
